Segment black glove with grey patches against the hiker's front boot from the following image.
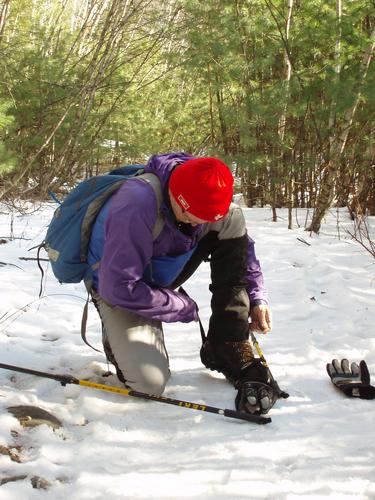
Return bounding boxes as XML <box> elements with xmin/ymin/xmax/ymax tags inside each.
<box><xmin>235</xmin><ymin>359</ymin><xmax>284</xmax><ymax>415</ymax></box>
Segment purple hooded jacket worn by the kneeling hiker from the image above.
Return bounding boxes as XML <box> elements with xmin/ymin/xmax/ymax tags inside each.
<box><xmin>93</xmin><ymin>153</ymin><xmax>267</xmax><ymax>323</ymax></box>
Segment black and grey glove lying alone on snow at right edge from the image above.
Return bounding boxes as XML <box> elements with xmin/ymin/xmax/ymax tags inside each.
<box><xmin>327</xmin><ymin>359</ymin><xmax>375</xmax><ymax>399</ymax></box>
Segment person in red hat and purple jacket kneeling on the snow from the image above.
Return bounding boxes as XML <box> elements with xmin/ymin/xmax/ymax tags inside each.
<box><xmin>84</xmin><ymin>153</ymin><xmax>280</xmax><ymax>413</ymax></box>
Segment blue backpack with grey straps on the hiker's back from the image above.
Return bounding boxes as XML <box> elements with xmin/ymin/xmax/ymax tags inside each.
<box><xmin>41</xmin><ymin>165</ymin><xmax>164</xmax><ymax>283</ymax></box>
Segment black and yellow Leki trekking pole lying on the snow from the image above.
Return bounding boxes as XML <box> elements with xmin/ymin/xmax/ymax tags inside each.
<box><xmin>0</xmin><ymin>363</ymin><xmax>271</xmax><ymax>424</ymax></box>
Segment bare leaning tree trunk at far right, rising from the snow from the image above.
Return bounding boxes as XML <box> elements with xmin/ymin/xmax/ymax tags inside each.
<box><xmin>307</xmin><ymin>22</ymin><xmax>375</xmax><ymax>233</ymax></box>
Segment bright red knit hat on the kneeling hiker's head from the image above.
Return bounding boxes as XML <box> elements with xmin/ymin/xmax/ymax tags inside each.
<box><xmin>169</xmin><ymin>158</ymin><xmax>233</xmax><ymax>222</ymax></box>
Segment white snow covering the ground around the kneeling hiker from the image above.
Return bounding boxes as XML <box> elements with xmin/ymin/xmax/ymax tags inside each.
<box><xmin>0</xmin><ymin>201</ymin><xmax>375</xmax><ymax>500</ymax></box>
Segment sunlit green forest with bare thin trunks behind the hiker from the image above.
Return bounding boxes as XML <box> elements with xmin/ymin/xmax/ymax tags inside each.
<box><xmin>0</xmin><ymin>0</ymin><xmax>375</xmax><ymax>232</ymax></box>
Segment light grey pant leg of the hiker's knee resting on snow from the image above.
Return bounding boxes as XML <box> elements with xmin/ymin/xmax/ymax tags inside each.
<box><xmin>91</xmin><ymin>290</ymin><xmax>170</xmax><ymax>396</ymax></box>
